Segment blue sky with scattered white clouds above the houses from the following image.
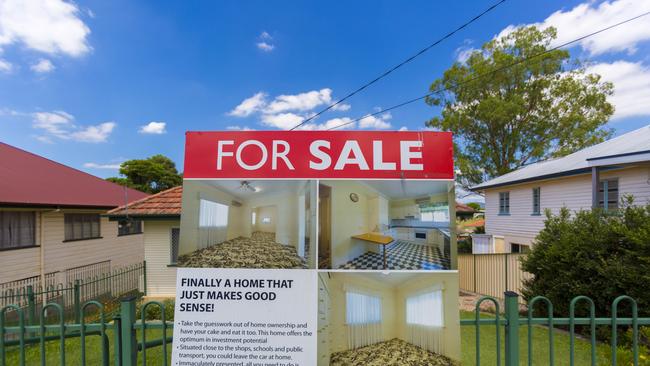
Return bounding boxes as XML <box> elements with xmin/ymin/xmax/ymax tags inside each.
<box><xmin>0</xmin><ymin>0</ymin><xmax>650</xmax><ymax>177</ymax></box>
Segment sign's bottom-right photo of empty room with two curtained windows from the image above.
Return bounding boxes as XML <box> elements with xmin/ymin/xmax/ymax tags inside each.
<box><xmin>318</xmin><ymin>271</ymin><xmax>460</xmax><ymax>366</ymax></box>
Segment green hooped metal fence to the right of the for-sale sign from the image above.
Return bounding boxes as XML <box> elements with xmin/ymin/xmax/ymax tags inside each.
<box><xmin>461</xmin><ymin>291</ymin><xmax>650</xmax><ymax>366</ymax></box>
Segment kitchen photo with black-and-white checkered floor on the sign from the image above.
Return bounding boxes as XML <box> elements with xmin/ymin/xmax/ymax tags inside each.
<box><xmin>318</xmin><ymin>180</ymin><xmax>457</xmax><ymax>270</ymax></box>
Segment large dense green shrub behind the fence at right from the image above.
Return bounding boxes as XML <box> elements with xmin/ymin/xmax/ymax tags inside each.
<box><xmin>522</xmin><ymin>198</ymin><xmax>650</xmax><ymax>334</ymax></box>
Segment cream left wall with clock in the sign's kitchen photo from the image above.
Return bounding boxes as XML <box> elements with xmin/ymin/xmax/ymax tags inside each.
<box><xmin>320</xmin><ymin>180</ymin><xmax>377</xmax><ymax>268</ymax></box>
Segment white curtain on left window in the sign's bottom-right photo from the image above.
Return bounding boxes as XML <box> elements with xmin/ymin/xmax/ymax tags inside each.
<box><xmin>345</xmin><ymin>292</ymin><xmax>383</xmax><ymax>349</ymax></box>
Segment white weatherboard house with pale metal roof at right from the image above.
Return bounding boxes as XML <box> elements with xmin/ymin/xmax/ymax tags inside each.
<box><xmin>472</xmin><ymin>125</ymin><xmax>650</xmax><ymax>253</ymax></box>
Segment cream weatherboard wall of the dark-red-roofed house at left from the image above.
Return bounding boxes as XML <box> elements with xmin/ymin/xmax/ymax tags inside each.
<box><xmin>0</xmin><ymin>209</ymin><xmax>144</xmax><ymax>282</ymax></box>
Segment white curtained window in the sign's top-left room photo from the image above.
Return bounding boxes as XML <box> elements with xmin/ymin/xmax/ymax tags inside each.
<box><xmin>198</xmin><ymin>199</ymin><xmax>228</xmax><ymax>248</ymax></box>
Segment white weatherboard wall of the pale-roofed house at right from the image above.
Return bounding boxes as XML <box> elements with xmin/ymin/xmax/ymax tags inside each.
<box><xmin>485</xmin><ymin>166</ymin><xmax>650</xmax><ymax>245</ymax></box>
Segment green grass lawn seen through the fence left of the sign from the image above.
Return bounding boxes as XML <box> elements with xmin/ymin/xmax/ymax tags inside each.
<box><xmin>5</xmin><ymin>329</ymin><xmax>172</xmax><ymax>366</ymax></box>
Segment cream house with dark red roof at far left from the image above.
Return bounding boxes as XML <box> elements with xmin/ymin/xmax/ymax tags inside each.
<box><xmin>0</xmin><ymin>143</ymin><xmax>147</xmax><ymax>291</ymax></box>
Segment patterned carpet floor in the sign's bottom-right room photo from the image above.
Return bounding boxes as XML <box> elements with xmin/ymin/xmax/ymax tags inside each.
<box><xmin>330</xmin><ymin>338</ymin><xmax>460</xmax><ymax>366</ymax></box>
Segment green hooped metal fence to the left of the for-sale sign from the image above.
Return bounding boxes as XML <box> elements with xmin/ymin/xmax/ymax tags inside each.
<box><xmin>0</xmin><ymin>297</ymin><xmax>174</xmax><ymax>366</ymax></box>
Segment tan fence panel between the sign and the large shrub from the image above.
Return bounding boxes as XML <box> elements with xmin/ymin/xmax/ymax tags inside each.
<box><xmin>458</xmin><ymin>253</ymin><xmax>532</xmax><ymax>299</ymax></box>
